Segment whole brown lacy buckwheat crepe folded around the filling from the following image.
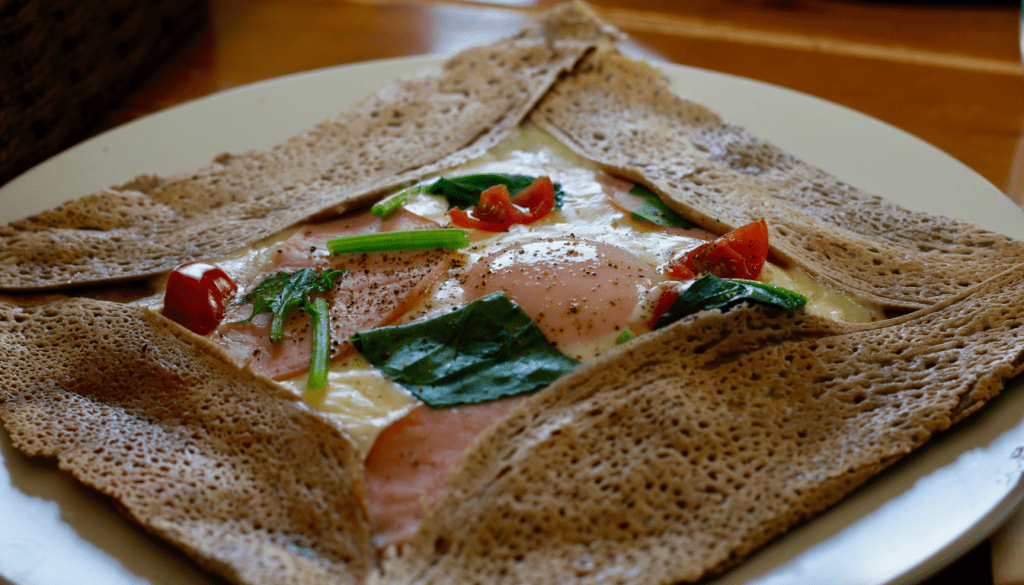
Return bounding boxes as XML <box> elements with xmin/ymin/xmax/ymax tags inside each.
<box><xmin>0</xmin><ymin>4</ymin><xmax>1024</xmax><ymax>583</ymax></box>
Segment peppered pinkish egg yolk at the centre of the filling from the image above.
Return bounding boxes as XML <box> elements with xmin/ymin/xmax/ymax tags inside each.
<box><xmin>463</xmin><ymin>239</ymin><xmax>663</xmax><ymax>360</ymax></box>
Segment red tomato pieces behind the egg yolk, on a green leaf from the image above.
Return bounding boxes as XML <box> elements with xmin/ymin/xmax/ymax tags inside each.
<box><xmin>449</xmin><ymin>176</ymin><xmax>555</xmax><ymax>232</ymax></box>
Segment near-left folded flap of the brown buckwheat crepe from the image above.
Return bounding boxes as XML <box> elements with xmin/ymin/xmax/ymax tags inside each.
<box><xmin>0</xmin><ymin>298</ymin><xmax>376</xmax><ymax>585</ymax></box>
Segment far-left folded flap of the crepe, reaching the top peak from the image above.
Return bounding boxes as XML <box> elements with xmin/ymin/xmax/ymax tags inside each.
<box><xmin>0</xmin><ymin>0</ymin><xmax>615</xmax><ymax>291</ymax></box>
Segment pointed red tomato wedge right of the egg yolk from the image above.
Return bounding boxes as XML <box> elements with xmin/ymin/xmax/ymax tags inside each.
<box><xmin>665</xmin><ymin>218</ymin><xmax>768</xmax><ymax>281</ymax></box>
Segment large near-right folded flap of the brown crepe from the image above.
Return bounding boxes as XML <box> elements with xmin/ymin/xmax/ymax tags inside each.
<box><xmin>385</xmin><ymin>265</ymin><xmax>1024</xmax><ymax>585</ymax></box>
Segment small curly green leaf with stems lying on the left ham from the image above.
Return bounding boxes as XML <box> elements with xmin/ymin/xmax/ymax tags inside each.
<box><xmin>239</xmin><ymin>268</ymin><xmax>344</xmax><ymax>388</ymax></box>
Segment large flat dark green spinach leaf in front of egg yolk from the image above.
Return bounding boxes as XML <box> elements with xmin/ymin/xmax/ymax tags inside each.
<box><xmin>351</xmin><ymin>292</ymin><xmax>579</xmax><ymax>408</ymax></box>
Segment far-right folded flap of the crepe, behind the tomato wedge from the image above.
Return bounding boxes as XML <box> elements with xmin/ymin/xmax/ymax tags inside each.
<box><xmin>531</xmin><ymin>51</ymin><xmax>1024</xmax><ymax>309</ymax></box>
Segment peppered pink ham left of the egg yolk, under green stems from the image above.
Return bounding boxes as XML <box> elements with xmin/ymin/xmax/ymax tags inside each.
<box><xmin>212</xmin><ymin>210</ymin><xmax>451</xmax><ymax>380</ymax></box>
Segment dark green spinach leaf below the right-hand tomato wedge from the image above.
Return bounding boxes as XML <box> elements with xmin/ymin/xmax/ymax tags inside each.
<box><xmin>654</xmin><ymin>273</ymin><xmax>807</xmax><ymax>329</ymax></box>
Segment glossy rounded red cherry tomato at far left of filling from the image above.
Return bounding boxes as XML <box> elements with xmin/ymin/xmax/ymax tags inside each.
<box><xmin>164</xmin><ymin>262</ymin><xmax>239</xmax><ymax>335</ymax></box>
